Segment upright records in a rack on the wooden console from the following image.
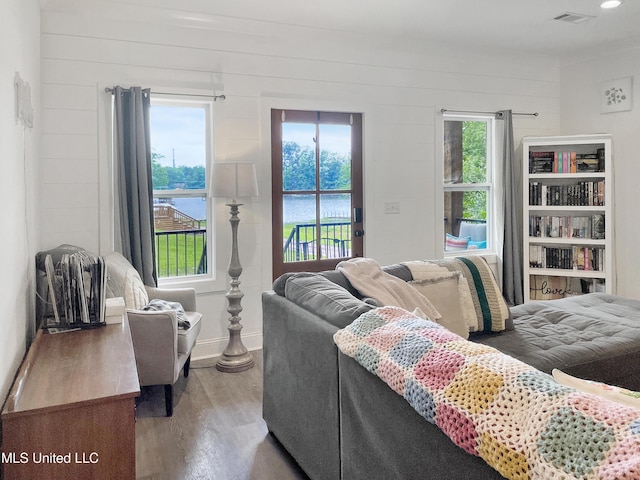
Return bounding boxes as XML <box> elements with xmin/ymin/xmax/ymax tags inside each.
<box><xmin>42</xmin><ymin>250</ymin><xmax>107</xmax><ymax>327</ymax></box>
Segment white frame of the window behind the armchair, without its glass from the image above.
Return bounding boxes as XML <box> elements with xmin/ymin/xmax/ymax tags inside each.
<box><xmin>150</xmin><ymin>93</ymin><xmax>219</xmax><ymax>292</ymax></box>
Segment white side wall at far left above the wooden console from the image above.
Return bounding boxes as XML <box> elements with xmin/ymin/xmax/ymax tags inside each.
<box><xmin>0</xmin><ymin>0</ymin><xmax>41</xmax><ymax>401</ymax></box>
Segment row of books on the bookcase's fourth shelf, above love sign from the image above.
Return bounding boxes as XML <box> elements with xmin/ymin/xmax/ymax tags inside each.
<box><xmin>529</xmin><ymin>245</ymin><xmax>605</xmax><ymax>272</ymax></box>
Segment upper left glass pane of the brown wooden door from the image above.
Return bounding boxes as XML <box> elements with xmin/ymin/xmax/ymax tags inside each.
<box><xmin>282</xmin><ymin>123</ymin><xmax>316</xmax><ymax>192</ymax></box>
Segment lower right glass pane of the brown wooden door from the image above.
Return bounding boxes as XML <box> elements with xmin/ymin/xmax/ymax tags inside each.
<box><xmin>320</xmin><ymin>194</ymin><xmax>351</xmax><ymax>258</ymax></box>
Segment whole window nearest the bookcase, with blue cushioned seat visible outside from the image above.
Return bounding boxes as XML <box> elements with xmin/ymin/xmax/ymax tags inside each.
<box><xmin>444</xmin><ymin>114</ymin><xmax>495</xmax><ymax>253</ymax></box>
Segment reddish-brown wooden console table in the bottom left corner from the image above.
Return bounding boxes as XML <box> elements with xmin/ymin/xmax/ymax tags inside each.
<box><xmin>2</xmin><ymin>321</ymin><xmax>140</xmax><ymax>480</ymax></box>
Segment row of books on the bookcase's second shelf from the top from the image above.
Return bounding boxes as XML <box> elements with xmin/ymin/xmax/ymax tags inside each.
<box><xmin>529</xmin><ymin>180</ymin><xmax>604</xmax><ymax>207</ymax></box>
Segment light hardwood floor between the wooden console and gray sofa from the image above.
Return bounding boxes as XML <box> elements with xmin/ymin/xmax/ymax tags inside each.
<box><xmin>136</xmin><ymin>351</ymin><xmax>308</xmax><ymax>480</ymax></box>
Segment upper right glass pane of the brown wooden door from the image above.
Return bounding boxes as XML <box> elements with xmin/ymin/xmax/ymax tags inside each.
<box><xmin>319</xmin><ymin>124</ymin><xmax>351</xmax><ymax>190</ymax></box>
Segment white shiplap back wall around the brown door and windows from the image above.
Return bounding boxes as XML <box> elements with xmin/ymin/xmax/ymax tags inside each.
<box><xmin>40</xmin><ymin>5</ymin><xmax>560</xmax><ymax>355</ymax></box>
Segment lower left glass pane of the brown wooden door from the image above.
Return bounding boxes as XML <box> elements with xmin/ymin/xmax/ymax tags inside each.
<box><xmin>282</xmin><ymin>195</ymin><xmax>317</xmax><ymax>262</ymax></box>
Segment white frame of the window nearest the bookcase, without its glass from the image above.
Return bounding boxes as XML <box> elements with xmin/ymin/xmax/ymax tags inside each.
<box><xmin>440</xmin><ymin>112</ymin><xmax>499</xmax><ymax>257</ymax></box>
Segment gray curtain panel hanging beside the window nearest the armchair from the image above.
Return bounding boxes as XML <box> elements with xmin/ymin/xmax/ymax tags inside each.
<box><xmin>114</xmin><ymin>87</ymin><xmax>157</xmax><ymax>287</ymax></box>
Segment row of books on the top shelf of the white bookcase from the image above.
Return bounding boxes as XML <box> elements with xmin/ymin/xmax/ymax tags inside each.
<box><xmin>529</xmin><ymin>148</ymin><xmax>604</xmax><ymax>174</ymax></box>
